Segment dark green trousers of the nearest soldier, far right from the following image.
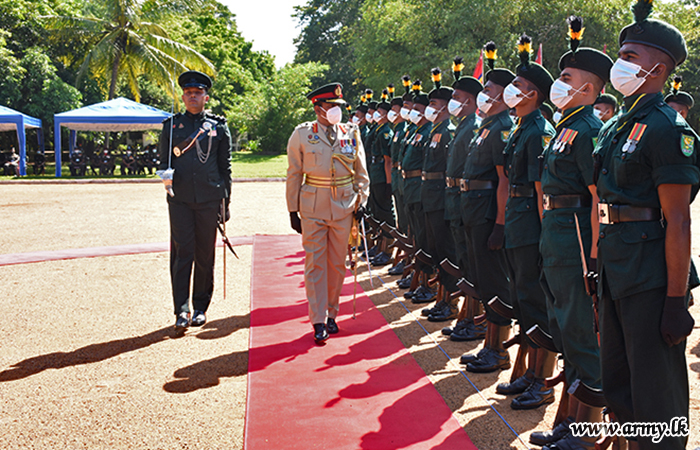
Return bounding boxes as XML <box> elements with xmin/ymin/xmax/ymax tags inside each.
<box><xmin>600</xmin><ymin>270</ymin><xmax>690</xmax><ymax>450</ymax></box>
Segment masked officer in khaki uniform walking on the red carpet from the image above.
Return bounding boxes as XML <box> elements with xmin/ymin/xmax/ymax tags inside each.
<box><xmin>287</xmin><ymin>83</ymin><xmax>369</xmax><ymax>343</ymax></box>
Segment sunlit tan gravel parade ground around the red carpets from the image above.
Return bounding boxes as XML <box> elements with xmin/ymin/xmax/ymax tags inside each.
<box><xmin>0</xmin><ymin>182</ymin><xmax>700</xmax><ymax>450</ymax></box>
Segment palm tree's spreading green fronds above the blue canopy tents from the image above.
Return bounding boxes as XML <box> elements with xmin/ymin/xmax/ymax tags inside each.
<box><xmin>43</xmin><ymin>0</ymin><xmax>214</xmax><ymax>101</ymax></box>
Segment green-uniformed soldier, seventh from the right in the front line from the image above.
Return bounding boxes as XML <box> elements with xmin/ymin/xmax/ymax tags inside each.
<box><xmin>401</xmin><ymin>84</ymin><xmax>436</xmax><ymax>303</ymax></box>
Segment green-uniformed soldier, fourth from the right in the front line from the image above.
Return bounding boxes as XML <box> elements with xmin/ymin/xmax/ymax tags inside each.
<box><xmin>460</xmin><ymin>42</ymin><xmax>515</xmax><ymax>372</ymax></box>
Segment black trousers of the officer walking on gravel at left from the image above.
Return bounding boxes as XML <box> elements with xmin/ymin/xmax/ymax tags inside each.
<box><xmin>168</xmin><ymin>199</ymin><xmax>221</xmax><ymax>315</ymax></box>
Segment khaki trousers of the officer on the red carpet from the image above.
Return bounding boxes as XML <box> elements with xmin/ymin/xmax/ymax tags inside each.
<box><xmin>301</xmin><ymin>214</ymin><xmax>352</xmax><ymax>324</ymax></box>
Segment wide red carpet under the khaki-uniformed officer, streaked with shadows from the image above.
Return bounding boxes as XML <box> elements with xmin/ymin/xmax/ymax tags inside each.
<box><xmin>245</xmin><ymin>236</ymin><xmax>476</xmax><ymax>450</ymax></box>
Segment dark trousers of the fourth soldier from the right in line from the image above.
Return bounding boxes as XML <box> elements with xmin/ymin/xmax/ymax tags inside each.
<box><xmin>464</xmin><ymin>220</ymin><xmax>511</xmax><ymax>326</ymax></box>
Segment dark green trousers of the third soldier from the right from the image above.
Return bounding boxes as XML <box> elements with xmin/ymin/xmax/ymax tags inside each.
<box><xmin>506</xmin><ymin>244</ymin><xmax>549</xmax><ymax>347</ymax></box>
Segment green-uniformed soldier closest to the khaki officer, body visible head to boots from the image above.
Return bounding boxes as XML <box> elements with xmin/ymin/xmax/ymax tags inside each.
<box><xmin>367</xmin><ymin>89</ymin><xmax>396</xmax><ymax>266</ymax></box>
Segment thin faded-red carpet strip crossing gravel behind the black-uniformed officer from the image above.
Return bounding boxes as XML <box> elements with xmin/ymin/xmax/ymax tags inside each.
<box><xmin>0</xmin><ymin>236</ymin><xmax>253</xmax><ymax>266</ymax></box>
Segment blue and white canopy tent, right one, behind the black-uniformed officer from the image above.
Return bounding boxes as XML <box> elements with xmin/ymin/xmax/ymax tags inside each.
<box><xmin>53</xmin><ymin>97</ymin><xmax>170</xmax><ymax>177</ymax></box>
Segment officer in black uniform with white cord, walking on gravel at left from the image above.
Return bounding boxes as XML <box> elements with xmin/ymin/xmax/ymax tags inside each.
<box><xmin>159</xmin><ymin>71</ymin><xmax>231</xmax><ymax>329</ymax></box>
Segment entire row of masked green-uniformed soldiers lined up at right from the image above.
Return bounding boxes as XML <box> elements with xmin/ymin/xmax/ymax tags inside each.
<box><xmin>349</xmin><ymin>1</ymin><xmax>700</xmax><ymax>449</ymax></box>
